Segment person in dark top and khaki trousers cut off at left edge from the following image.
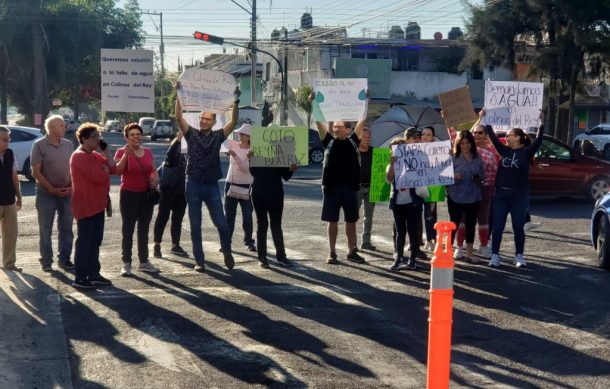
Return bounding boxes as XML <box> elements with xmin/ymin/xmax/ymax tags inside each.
<box><xmin>0</xmin><ymin>126</ymin><xmax>21</xmax><ymax>271</ymax></box>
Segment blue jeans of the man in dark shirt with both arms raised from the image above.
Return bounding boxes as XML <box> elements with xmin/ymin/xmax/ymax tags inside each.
<box><xmin>185</xmin><ymin>178</ymin><xmax>231</xmax><ymax>265</ymax></box>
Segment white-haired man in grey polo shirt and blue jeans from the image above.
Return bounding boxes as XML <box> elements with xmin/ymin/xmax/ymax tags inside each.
<box><xmin>30</xmin><ymin>115</ymin><xmax>74</xmax><ymax>272</ymax></box>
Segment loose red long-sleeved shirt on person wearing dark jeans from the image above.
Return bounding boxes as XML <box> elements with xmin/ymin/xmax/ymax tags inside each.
<box><xmin>70</xmin><ymin>148</ymin><xmax>114</xmax><ymax>221</ymax></box>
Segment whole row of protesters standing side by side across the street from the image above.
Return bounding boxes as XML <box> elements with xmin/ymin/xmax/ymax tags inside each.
<box><xmin>0</xmin><ymin>84</ymin><xmax>542</xmax><ymax>288</ymax></box>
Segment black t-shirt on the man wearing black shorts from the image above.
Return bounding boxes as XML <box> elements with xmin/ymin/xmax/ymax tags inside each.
<box><xmin>322</xmin><ymin>133</ymin><xmax>360</xmax><ymax>190</ymax></box>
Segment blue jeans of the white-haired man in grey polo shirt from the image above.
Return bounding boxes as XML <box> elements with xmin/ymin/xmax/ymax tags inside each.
<box><xmin>36</xmin><ymin>186</ymin><xmax>74</xmax><ymax>266</ymax></box>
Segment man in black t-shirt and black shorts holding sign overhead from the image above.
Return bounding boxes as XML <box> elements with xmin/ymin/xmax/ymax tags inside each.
<box><xmin>309</xmin><ymin>91</ymin><xmax>366</xmax><ymax>264</ymax></box>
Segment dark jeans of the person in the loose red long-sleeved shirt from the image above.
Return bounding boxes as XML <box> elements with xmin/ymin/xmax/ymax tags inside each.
<box><xmin>74</xmin><ymin>211</ymin><xmax>104</xmax><ymax>281</ymax></box>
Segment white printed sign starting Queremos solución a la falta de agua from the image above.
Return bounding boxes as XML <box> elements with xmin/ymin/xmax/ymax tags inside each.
<box><xmin>100</xmin><ymin>49</ymin><xmax>155</xmax><ymax>112</ymax></box>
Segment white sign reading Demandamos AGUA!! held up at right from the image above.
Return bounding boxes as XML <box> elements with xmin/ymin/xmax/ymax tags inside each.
<box><xmin>484</xmin><ymin>81</ymin><xmax>544</xmax><ymax>129</ymax></box>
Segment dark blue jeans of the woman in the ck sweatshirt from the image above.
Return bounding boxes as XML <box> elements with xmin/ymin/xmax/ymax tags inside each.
<box><xmin>491</xmin><ymin>189</ymin><xmax>529</xmax><ymax>254</ymax></box>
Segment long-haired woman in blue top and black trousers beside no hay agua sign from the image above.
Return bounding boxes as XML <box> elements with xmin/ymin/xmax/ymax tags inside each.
<box><xmin>447</xmin><ymin>130</ymin><xmax>484</xmax><ymax>263</ymax></box>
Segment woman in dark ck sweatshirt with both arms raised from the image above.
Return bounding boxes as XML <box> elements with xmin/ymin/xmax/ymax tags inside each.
<box><xmin>479</xmin><ymin>109</ymin><xmax>544</xmax><ymax>267</ymax></box>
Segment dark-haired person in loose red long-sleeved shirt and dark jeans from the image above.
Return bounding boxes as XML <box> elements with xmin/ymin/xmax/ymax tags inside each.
<box><xmin>70</xmin><ymin>123</ymin><xmax>116</xmax><ymax>289</ymax></box>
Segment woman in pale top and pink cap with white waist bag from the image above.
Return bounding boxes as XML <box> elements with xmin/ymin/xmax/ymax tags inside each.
<box><xmin>225</xmin><ymin>124</ymin><xmax>256</xmax><ymax>251</ymax></box>
